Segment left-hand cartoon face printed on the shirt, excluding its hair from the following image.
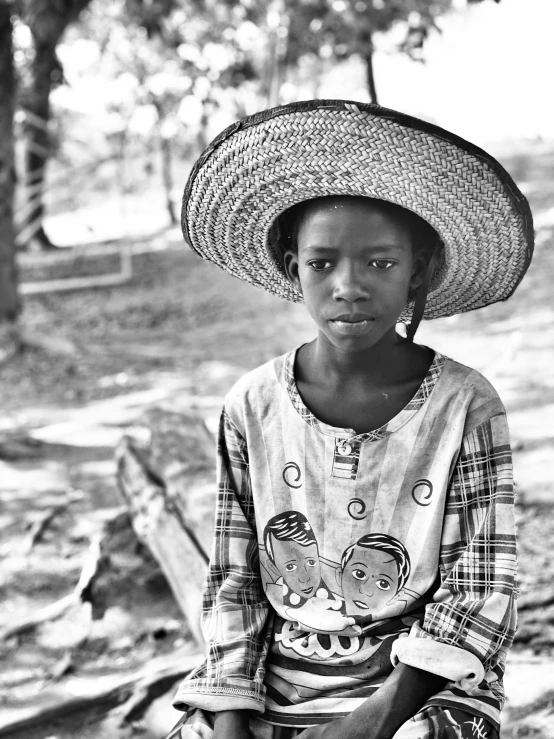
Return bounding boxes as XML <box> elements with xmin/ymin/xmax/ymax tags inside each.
<box><xmin>272</xmin><ymin>537</ymin><xmax>321</xmax><ymax>598</ymax></box>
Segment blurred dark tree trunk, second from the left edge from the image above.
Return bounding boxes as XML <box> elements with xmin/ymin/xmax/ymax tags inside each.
<box><xmin>19</xmin><ymin>39</ymin><xmax>57</xmax><ymax>249</ymax></box>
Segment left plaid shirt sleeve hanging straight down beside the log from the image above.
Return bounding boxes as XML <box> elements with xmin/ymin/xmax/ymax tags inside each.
<box><xmin>170</xmin><ymin>409</ymin><xmax>270</xmax><ymax>712</ymax></box>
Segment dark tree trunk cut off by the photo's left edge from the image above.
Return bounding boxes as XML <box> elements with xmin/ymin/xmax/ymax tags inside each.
<box><xmin>0</xmin><ymin>3</ymin><xmax>20</xmax><ymax>326</ymax></box>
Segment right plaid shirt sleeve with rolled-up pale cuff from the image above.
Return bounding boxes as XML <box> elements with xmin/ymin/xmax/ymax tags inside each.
<box><xmin>390</xmin><ymin>413</ymin><xmax>517</xmax><ymax>683</ymax></box>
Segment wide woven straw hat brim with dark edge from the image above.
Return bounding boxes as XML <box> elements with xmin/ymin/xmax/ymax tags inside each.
<box><xmin>182</xmin><ymin>100</ymin><xmax>533</xmax><ymax>318</ymax></box>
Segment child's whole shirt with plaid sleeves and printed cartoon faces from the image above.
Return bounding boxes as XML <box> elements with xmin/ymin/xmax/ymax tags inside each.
<box><xmin>175</xmin><ymin>352</ymin><xmax>517</xmax><ymax>726</ymax></box>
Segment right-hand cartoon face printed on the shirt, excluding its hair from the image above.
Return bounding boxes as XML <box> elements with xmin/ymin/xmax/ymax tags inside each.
<box><xmin>341</xmin><ymin>547</ymin><xmax>398</xmax><ymax>616</ymax></box>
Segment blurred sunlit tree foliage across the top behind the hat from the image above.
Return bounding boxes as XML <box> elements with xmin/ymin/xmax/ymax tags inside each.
<box><xmin>12</xmin><ymin>0</ymin><xmax>504</xmax><ymax>218</ymax></box>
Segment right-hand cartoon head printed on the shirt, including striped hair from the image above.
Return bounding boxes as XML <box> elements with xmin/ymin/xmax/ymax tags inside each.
<box><xmin>340</xmin><ymin>534</ymin><xmax>410</xmax><ymax>616</ymax></box>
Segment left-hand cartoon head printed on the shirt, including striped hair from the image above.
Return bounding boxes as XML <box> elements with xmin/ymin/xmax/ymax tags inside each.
<box><xmin>264</xmin><ymin>511</ymin><xmax>321</xmax><ymax>598</ymax></box>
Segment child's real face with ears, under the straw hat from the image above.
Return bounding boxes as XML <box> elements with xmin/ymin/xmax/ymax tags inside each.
<box><xmin>285</xmin><ymin>197</ymin><xmax>425</xmax><ymax>351</ymax></box>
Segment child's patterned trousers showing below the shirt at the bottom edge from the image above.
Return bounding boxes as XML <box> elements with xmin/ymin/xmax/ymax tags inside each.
<box><xmin>166</xmin><ymin>706</ymin><xmax>498</xmax><ymax>739</ymax></box>
